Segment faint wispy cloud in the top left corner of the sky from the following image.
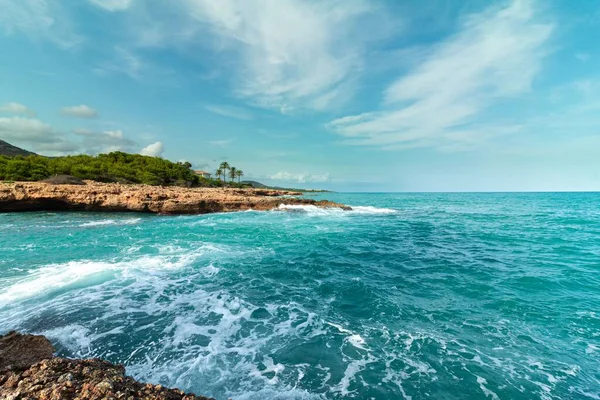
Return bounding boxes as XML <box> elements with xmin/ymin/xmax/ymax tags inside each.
<box><xmin>0</xmin><ymin>0</ymin><xmax>83</xmax><ymax>49</ymax></box>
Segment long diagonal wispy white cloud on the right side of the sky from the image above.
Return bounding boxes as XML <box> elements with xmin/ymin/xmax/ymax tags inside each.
<box><xmin>328</xmin><ymin>0</ymin><xmax>553</xmax><ymax>148</ymax></box>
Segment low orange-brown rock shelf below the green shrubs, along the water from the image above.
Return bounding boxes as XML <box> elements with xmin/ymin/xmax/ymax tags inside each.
<box><xmin>0</xmin><ymin>181</ymin><xmax>350</xmax><ymax>214</ymax></box>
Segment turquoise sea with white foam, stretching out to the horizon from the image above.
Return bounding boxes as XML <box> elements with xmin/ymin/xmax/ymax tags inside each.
<box><xmin>0</xmin><ymin>193</ymin><xmax>600</xmax><ymax>400</ymax></box>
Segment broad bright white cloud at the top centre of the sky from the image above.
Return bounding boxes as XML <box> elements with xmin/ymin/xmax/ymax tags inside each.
<box><xmin>188</xmin><ymin>0</ymin><xmax>376</xmax><ymax>109</ymax></box>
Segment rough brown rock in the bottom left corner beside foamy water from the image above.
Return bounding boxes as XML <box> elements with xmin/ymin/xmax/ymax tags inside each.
<box><xmin>0</xmin><ymin>332</ymin><xmax>211</xmax><ymax>400</ymax></box>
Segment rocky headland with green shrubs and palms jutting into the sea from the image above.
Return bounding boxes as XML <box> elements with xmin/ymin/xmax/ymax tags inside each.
<box><xmin>0</xmin><ymin>142</ymin><xmax>349</xmax><ymax>215</ymax></box>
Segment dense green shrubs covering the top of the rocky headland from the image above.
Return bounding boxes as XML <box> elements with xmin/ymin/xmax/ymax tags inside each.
<box><xmin>0</xmin><ymin>152</ymin><xmax>244</xmax><ymax>187</ymax></box>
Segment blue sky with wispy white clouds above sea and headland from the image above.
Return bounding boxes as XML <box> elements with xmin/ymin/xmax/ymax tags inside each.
<box><xmin>0</xmin><ymin>0</ymin><xmax>600</xmax><ymax>192</ymax></box>
